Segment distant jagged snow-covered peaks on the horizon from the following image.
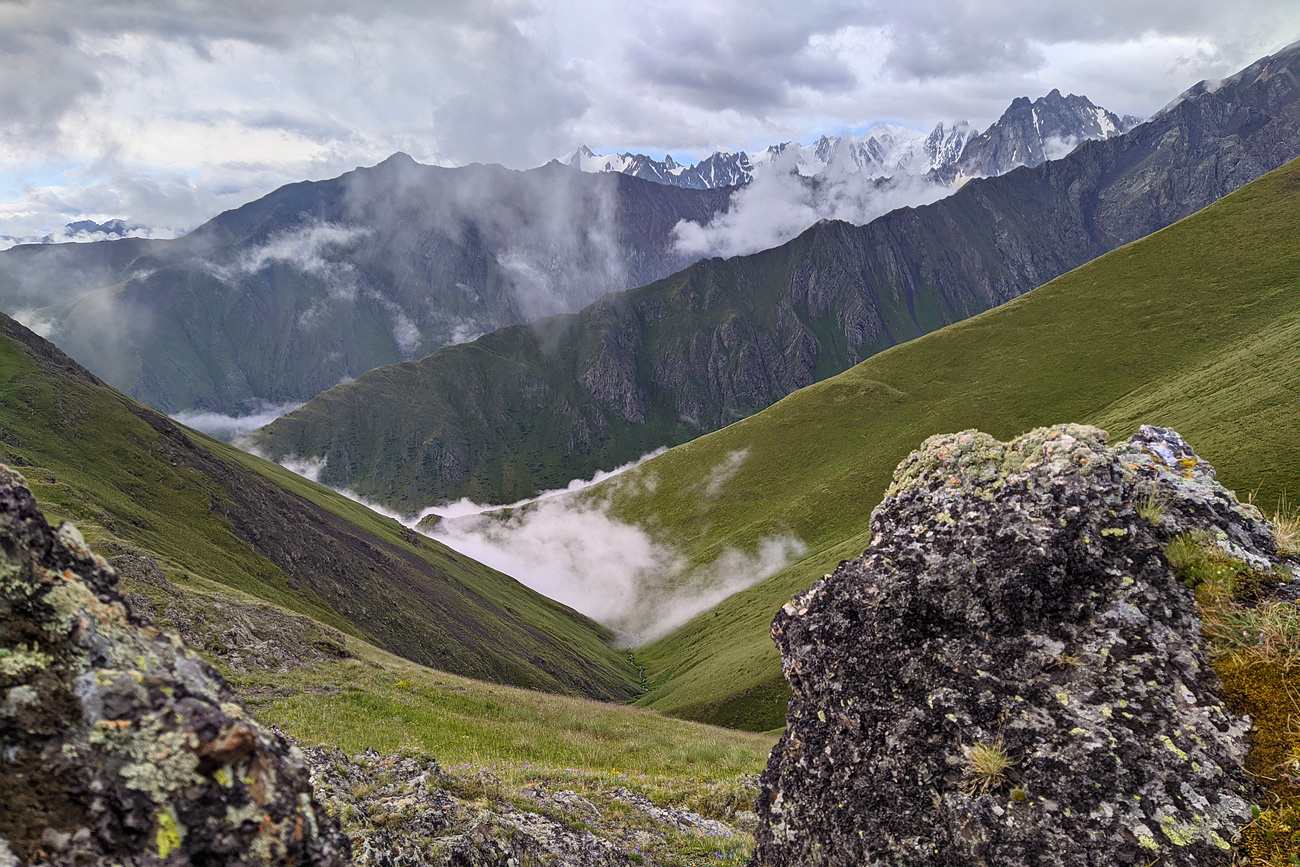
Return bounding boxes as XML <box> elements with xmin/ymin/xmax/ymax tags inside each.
<box><xmin>560</xmin><ymin>90</ymin><xmax>1140</xmax><ymax>190</ymax></box>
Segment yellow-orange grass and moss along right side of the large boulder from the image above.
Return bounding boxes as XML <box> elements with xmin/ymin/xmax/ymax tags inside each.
<box><xmin>1165</xmin><ymin>535</ymin><xmax>1300</xmax><ymax>867</ymax></box>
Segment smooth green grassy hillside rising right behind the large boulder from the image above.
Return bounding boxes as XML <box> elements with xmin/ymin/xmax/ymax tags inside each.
<box><xmin>603</xmin><ymin>162</ymin><xmax>1300</xmax><ymax>731</ymax></box>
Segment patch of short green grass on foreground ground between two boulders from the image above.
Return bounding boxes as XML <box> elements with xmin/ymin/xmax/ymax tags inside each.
<box><xmin>228</xmin><ymin>640</ymin><xmax>775</xmax><ymax>867</ymax></box>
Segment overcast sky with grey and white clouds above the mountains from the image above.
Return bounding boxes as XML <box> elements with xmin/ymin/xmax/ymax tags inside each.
<box><xmin>0</xmin><ymin>0</ymin><xmax>1300</xmax><ymax>243</ymax></box>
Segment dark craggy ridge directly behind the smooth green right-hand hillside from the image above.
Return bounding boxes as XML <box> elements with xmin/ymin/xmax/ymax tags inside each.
<box><xmin>252</xmin><ymin>45</ymin><xmax>1300</xmax><ymax>511</ymax></box>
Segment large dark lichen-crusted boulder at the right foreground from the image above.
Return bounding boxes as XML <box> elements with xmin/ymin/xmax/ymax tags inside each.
<box><xmin>751</xmin><ymin>425</ymin><xmax>1277</xmax><ymax>867</ymax></box>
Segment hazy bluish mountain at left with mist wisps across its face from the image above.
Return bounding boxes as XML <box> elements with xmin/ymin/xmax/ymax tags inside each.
<box><xmin>0</xmin><ymin>153</ymin><xmax>729</xmax><ymax>413</ymax></box>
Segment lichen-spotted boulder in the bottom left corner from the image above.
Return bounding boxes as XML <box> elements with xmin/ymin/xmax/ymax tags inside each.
<box><xmin>0</xmin><ymin>467</ymin><xmax>348</xmax><ymax>866</ymax></box>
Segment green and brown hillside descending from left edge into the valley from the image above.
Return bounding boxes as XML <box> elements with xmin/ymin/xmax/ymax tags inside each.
<box><xmin>0</xmin><ymin>316</ymin><xmax>634</xmax><ymax>698</ymax></box>
